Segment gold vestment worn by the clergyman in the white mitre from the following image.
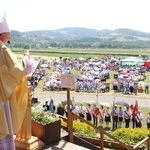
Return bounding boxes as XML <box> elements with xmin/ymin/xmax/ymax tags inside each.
<box><xmin>0</xmin><ymin>43</ymin><xmax>28</xmax><ymax>140</ymax></box>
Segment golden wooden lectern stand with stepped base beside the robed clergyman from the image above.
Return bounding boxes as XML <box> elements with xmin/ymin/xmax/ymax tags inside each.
<box><xmin>15</xmin><ymin>78</ymin><xmax>45</xmax><ymax>150</ymax></box>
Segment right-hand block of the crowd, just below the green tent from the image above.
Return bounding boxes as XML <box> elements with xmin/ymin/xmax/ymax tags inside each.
<box><xmin>112</xmin><ymin>65</ymin><xmax>149</xmax><ymax>95</ymax></box>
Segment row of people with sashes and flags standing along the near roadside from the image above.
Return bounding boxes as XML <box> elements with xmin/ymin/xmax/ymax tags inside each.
<box><xmin>43</xmin><ymin>100</ymin><xmax>150</xmax><ymax>130</ymax></box>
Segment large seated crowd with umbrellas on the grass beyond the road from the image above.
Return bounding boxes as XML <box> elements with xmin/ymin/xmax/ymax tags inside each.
<box><xmin>39</xmin><ymin>55</ymin><xmax>149</xmax><ymax>95</ymax></box>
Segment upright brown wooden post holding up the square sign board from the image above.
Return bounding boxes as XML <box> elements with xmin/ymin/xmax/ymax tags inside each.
<box><xmin>67</xmin><ymin>88</ymin><xmax>74</xmax><ymax>143</ymax></box>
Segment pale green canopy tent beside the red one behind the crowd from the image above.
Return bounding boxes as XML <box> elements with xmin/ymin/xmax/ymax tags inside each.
<box><xmin>120</xmin><ymin>57</ymin><xmax>145</xmax><ymax>66</ymax></box>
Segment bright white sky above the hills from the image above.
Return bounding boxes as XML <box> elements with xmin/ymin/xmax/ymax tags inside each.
<box><xmin>1</xmin><ymin>0</ymin><xmax>150</xmax><ymax>33</ymax></box>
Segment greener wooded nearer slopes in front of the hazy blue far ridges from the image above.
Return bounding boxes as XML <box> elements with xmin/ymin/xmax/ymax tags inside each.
<box><xmin>11</xmin><ymin>31</ymin><xmax>150</xmax><ymax>49</ymax></box>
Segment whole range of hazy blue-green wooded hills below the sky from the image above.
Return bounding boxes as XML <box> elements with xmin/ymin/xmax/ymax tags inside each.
<box><xmin>11</xmin><ymin>27</ymin><xmax>150</xmax><ymax>49</ymax></box>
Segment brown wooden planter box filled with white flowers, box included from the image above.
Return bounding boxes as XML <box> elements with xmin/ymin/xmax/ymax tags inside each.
<box><xmin>31</xmin><ymin>107</ymin><xmax>61</xmax><ymax>145</ymax></box>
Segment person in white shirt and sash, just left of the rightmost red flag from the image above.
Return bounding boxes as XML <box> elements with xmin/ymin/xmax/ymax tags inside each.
<box><xmin>124</xmin><ymin>107</ymin><xmax>132</xmax><ymax>128</ymax></box>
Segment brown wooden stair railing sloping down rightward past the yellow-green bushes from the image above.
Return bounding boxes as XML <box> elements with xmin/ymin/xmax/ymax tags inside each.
<box><xmin>60</xmin><ymin>112</ymin><xmax>150</xmax><ymax>150</ymax></box>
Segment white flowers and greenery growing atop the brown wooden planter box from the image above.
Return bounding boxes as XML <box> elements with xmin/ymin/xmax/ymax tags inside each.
<box><xmin>31</xmin><ymin>107</ymin><xmax>59</xmax><ymax>125</ymax></box>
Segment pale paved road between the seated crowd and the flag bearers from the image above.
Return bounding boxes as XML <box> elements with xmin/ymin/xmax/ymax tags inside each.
<box><xmin>33</xmin><ymin>91</ymin><xmax>150</xmax><ymax>108</ymax></box>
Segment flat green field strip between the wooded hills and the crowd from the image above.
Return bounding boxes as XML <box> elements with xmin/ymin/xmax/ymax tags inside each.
<box><xmin>14</xmin><ymin>48</ymin><xmax>150</xmax><ymax>58</ymax></box>
